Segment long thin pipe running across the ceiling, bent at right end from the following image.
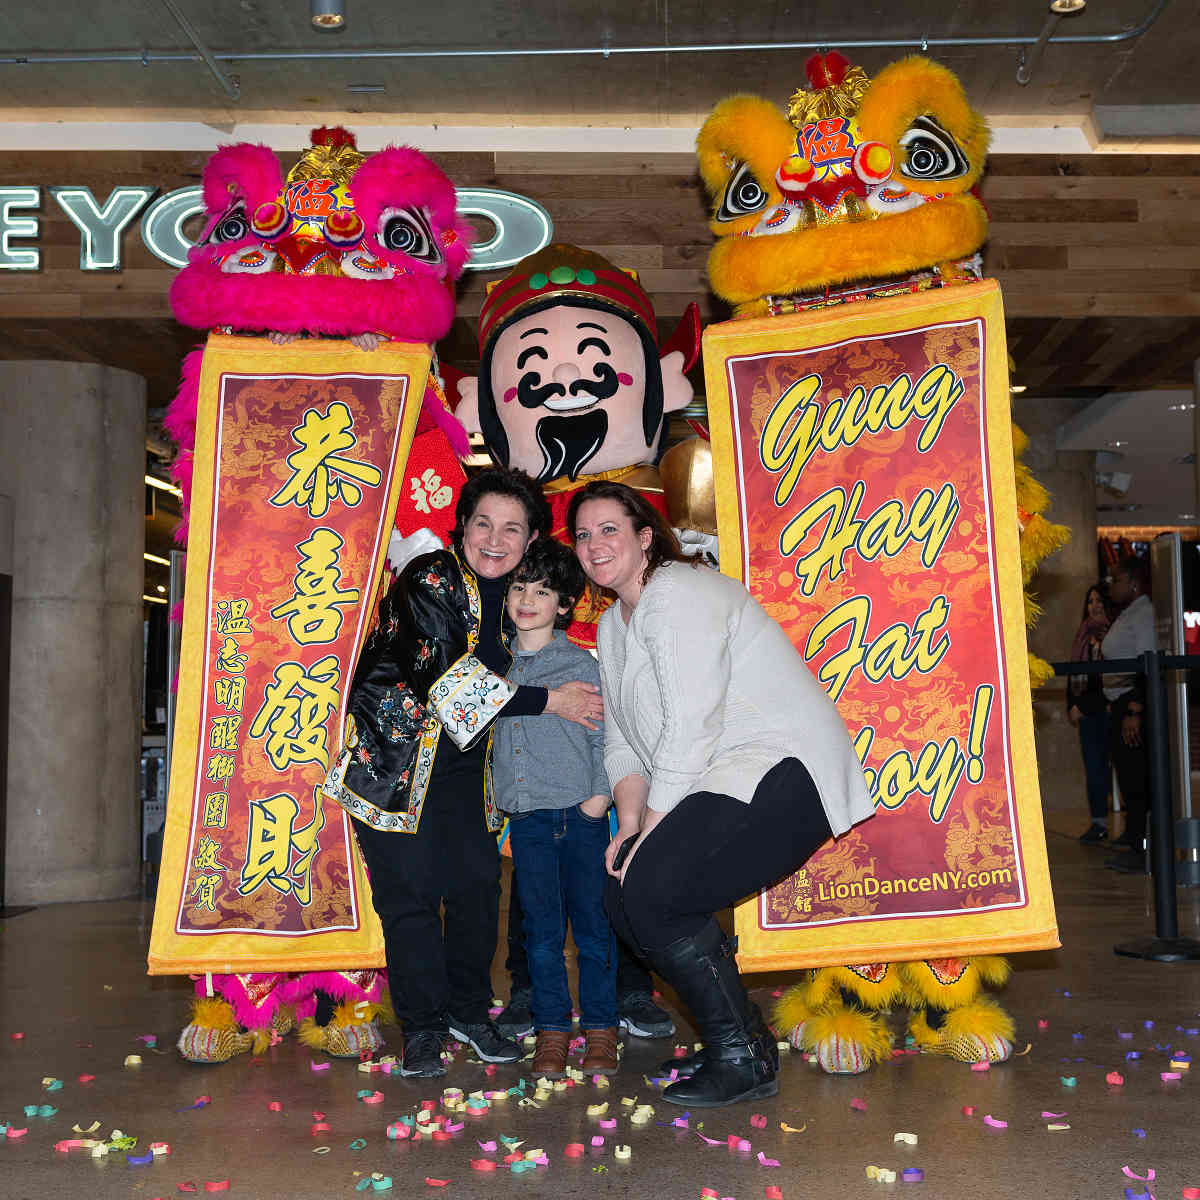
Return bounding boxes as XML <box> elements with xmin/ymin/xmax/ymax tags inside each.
<box><xmin>0</xmin><ymin>0</ymin><xmax>1170</xmax><ymax>73</ymax></box>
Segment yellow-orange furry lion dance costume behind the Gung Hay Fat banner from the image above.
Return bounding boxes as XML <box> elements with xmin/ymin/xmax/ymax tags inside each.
<box><xmin>697</xmin><ymin>54</ymin><xmax>1067</xmax><ymax>1074</ymax></box>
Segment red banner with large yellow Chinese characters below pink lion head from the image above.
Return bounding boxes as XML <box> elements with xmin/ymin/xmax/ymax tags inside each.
<box><xmin>149</xmin><ymin>335</ymin><xmax>430</xmax><ymax>974</ymax></box>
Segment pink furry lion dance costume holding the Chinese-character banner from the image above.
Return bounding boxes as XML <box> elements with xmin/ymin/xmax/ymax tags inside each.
<box><xmin>167</xmin><ymin>128</ymin><xmax>470</xmax><ymax>1062</ymax></box>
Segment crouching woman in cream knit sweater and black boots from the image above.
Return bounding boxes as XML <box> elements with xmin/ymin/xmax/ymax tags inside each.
<box><xmin>568</xmin><ymin>481</ymin><xmax>872</xmax><ymax>1108</ymax></box>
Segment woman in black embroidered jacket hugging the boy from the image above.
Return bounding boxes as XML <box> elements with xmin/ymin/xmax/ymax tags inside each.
<box><xmin>325</xmin><ymin>468</ymin><xmax>602</xmax><ymax>1075</ymax></box>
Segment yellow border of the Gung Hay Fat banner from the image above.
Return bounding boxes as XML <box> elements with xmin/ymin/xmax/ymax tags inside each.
<box><xmin>703</xmin><ymin>280</ymin><xmax>1061</xmax><ymax>971</ymax></box>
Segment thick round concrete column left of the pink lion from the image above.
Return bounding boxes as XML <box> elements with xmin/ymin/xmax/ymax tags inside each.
<box><xmin>0</xmin><ymin>362</ymin><xmax>146</xmax><ymax>905</ymax></box>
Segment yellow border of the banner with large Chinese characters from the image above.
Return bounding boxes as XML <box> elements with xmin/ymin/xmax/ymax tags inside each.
<box><xmin>146</xmin><ymin>334</ymin><xmax>432</xmax><ymax>976</ymax></box>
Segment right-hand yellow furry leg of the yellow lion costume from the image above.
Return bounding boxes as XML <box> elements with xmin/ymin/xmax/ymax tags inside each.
<box><xmin>900</xmin><ymin>955</ymin><xmax>1015</xmax><ymax>1062</ymax></box>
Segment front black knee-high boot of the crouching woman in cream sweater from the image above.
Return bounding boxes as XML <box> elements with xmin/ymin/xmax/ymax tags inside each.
<box><xmin>647</xmin><ymin>920</ymin><xmax>779</xmax><ymax>1109</ymax></box>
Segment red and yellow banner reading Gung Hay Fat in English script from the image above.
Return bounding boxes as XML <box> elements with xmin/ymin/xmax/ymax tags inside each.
<box><xmin>704</xmin><ymin>281</ymin><xmax>1058</xmax><ymax>970</ymax></box>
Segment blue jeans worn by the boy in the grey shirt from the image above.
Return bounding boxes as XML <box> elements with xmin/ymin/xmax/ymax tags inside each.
<box><xmin>509</xmin><ymin>806</ymin><xmax>618</xmax><ymax>1032</ymax></box>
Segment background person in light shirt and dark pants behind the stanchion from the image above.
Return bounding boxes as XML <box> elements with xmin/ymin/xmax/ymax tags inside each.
<box><xmin>1100</xmin><ymin>558</ymin><xmax>1157</xmax><ymax>875</ymax></box>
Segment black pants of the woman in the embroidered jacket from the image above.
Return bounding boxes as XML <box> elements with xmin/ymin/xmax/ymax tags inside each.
<box><xmin>354</xmin><ymin>770</ymin><xmax>500</xmax><ymax>1033</ymax></box>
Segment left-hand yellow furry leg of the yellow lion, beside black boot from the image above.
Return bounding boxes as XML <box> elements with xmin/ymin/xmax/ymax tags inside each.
<box><xmin>775</xmin><ymin>962</ymin><xmax>900</xmax><ymax>1075</ymax></box>
